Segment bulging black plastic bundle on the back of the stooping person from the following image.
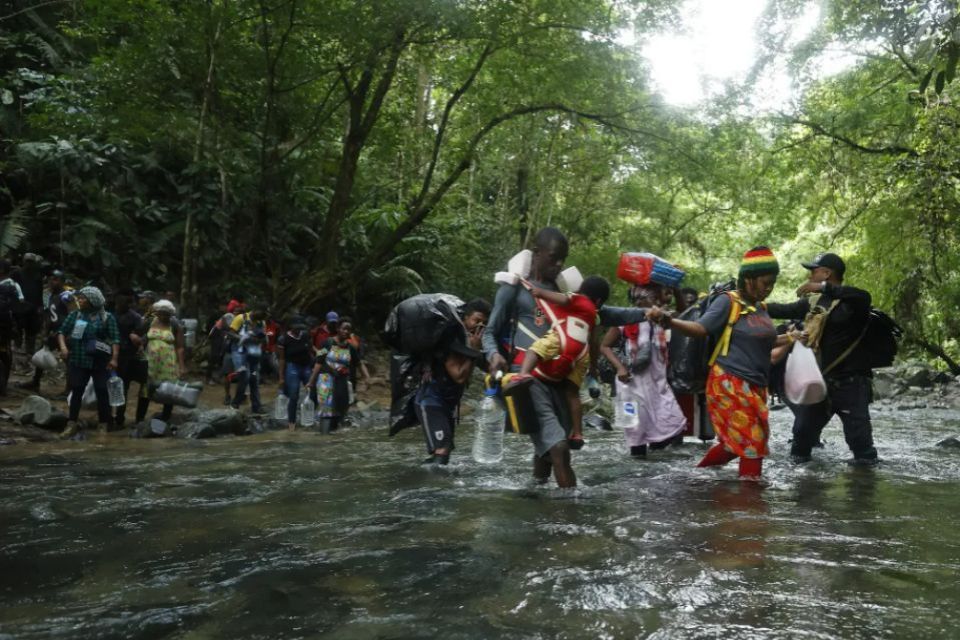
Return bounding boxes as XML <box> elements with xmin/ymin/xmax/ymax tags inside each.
<box><xmin>383</xmin><ymin>293</ymin><xmax>467</xmax><ymax>357</ymax></box>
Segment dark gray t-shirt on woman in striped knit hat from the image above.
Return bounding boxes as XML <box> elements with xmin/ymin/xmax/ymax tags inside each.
<box><xmin>697</xmin><ymin>294</ymin><xmax>777</xmax><ymax>387</ymax></box>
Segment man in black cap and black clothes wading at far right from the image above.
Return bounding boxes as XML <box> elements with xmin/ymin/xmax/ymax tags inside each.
<box><xmin>767</xmin><ymin>253</ymin><xmax>877</xmax><ymax>465</ymax></box>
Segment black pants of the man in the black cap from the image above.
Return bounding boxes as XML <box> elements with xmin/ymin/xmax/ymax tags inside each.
<box><xmin>790</xmin><ymin>375</ymin><xmax>877</xmax><ymax>459</ymax></box>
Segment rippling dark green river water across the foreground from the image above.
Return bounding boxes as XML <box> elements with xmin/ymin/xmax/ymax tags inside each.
<box><xmin>0</xmin><ymin>402</ymin><xmax>960</xmax><ymax>639</ymax></box>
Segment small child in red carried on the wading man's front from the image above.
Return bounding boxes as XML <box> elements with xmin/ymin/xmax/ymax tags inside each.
<box><xmin>503</xmin><ymin>276</ymin><xmax>610</xmax><ymax>449</ymax></box>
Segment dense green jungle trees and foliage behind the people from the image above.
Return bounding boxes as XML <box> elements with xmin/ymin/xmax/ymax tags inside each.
<box><xmin>0</xmin><ymin>0</ymin><xmax>960</xmax><ymax>373</ymax></box>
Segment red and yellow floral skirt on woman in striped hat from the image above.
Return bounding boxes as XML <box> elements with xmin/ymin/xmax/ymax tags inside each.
<box><xmin>707</xmin><ymin>364</ymin><xmax>770</xmax><ymax>458</ymax></box>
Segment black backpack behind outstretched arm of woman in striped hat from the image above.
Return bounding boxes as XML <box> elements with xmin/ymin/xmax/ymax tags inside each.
<box><xmin>667</xmin><ymin>280</ymin><xmax>737</xmax><ymax>394</ymax></box>
